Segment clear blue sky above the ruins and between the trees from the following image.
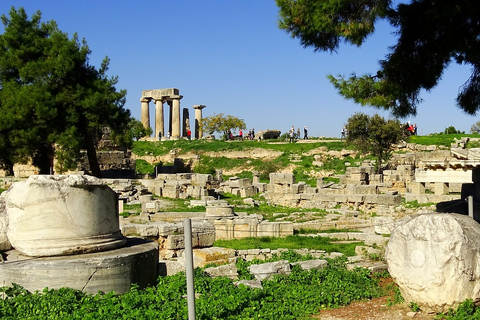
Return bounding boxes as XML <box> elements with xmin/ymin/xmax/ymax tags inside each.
<box><xmin>0</xmin><ymin>0</ymin><xmax>480</xmax><ymax>137</ymax></box>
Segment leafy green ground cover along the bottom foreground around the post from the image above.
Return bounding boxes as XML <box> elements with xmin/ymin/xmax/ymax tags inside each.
<box><xmin>0</xmin><ymin>257</ymin><xmax>382</xmax><ymax>320</ymax></box>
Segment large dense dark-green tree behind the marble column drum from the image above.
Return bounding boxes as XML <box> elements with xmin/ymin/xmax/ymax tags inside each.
<box><xmin>0</xmin><ymin>7</ymin><xmax>130</xmax><ymax>176</ymax></box>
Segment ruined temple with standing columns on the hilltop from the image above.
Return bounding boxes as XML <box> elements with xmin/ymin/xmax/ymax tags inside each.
<box><xmin>140</xmin><ymin>88</ymin><xmax>205</xmax><ymax>140</ymax></box>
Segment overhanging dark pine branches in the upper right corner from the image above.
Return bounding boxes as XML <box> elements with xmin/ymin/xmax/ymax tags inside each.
<box><xmin>276</xmin><ymin>0</ymin><xmax>480</xmax><ymax>117</ymax></box>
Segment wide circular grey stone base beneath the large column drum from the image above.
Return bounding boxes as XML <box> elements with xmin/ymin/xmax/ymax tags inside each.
<box><xmin>0</xmin><ymin>238</ymin><xmax>158</xmax><ymax>294</ymax></box>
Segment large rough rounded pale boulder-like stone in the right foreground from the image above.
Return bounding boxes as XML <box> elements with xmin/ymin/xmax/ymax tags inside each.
<box><xmin>385</xmin><ymin>213</ymin><xmax>480</xmax><ymax>312</ymax></box>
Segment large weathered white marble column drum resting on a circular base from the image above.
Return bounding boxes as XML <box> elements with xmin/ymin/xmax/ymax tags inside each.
<box><xmin>5</xmin><ymin>175</ymin><xmax>126</xmax><ymax>257</ymax></box>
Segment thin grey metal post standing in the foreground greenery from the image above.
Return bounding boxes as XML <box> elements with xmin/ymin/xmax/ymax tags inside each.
<box><xmin>183</xmin><ymin>219</ymin><xmax>195</xmax><ymax>320</ymax></box>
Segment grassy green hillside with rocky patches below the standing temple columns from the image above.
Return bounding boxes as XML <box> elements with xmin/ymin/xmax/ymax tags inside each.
<box><xmin>132</xmin><ymin>134</ymin><xmax>480</xmax><ymax>185</ymax></box>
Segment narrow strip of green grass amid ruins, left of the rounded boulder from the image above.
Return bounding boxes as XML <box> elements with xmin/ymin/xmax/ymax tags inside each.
<box><xmin>214</xmin><ymin>235</ymin><xmax>363</xmax><ymax>257</ymax></box>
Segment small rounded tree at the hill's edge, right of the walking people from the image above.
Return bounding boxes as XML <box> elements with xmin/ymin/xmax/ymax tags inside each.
<box><xmin>345</xmin><ymin>113</ymin><xmax>405</xmax><ymax>172</ymax></box>
